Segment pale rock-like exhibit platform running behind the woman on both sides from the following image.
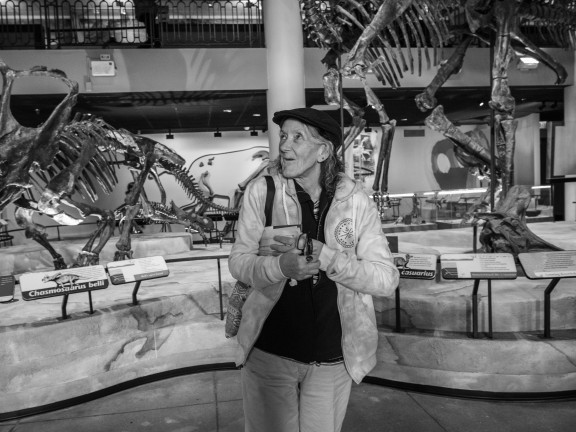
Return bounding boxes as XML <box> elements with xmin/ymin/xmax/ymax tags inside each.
<box><xmin>0</xmin><ymin>222</ymin><xmax>576</xmax><ymax>420</ymax></box>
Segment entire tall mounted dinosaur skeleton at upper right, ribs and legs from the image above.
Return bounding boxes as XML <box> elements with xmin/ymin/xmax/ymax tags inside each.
<box><xmin>300</xmin><ymin>0</ymin><xmax>576</xmax><ymax>253</ymax></box>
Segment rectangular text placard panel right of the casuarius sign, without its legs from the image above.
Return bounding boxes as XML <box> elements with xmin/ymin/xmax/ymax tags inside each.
<box><xmin>440</xmin><ymin>253</ymin><xmax>518</xmax><ymax>279</ymax></box>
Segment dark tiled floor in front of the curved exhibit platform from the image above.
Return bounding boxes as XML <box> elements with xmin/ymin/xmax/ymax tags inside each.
<box><xmin>0</xmin><ymin>371</ymin><xmax>576</xmax><ymax>432</ymax></box>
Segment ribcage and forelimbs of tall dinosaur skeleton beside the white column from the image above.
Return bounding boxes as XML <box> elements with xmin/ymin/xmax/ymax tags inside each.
<box><xmin>300</xmin><ymin>0</ymin><xmax>452</xmax><ymax>206</ymax></box>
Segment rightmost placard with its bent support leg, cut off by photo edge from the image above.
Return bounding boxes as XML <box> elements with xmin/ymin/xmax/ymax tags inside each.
<box><xmin>518</xmin><ymin>251</ymin><xmax>576</xmax><ymax>339</ymax></box>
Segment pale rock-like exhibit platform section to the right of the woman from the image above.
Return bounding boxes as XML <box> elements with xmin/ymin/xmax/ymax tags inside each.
<box><xmin>370</xmin><ymin>222</ymin><xmax>576</xmax><ymax>399</ymax></box>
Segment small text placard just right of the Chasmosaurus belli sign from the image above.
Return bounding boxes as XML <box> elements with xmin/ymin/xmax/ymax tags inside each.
<box><xmin>106</xmin><ymin>256</ymin><xmax>170</xmax><ymax>285</ymax></box>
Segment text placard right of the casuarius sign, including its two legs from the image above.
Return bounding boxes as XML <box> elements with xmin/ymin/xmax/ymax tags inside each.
<box><xmin>440</xmin><ymin>253</ymin><xmax>518</xmax><ymax>339</ymax></box>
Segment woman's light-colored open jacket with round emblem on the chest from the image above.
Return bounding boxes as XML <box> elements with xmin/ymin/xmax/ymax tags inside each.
<box><xmin>228</xmin><ymin>171</ymin><xmax>399</xmax><ymax>383</ymax></box>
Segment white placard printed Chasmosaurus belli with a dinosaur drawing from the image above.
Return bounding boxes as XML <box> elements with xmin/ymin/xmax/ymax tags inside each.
<box><xmin>20</xmin><ymin>265</ymin><xmax>108</xmax><ymax>300</ymax></box>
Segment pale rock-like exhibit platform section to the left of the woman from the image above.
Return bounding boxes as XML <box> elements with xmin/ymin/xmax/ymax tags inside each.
<box><xmin>0</xmin><ymin>245</ymin><xmax>235</xmax><ymax>419</ymax></box>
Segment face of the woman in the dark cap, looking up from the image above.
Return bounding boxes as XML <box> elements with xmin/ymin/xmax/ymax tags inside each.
<box><xmin>280</xmin><ymin>119</ymin><xmax>325</xmax><ymax>180</ymax></box>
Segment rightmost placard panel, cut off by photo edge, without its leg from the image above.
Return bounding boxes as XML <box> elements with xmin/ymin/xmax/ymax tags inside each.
<box><xmin>518</xmin><ymin>251</ymin><xmax>576</xmax><ymax>279</ymax></box>
